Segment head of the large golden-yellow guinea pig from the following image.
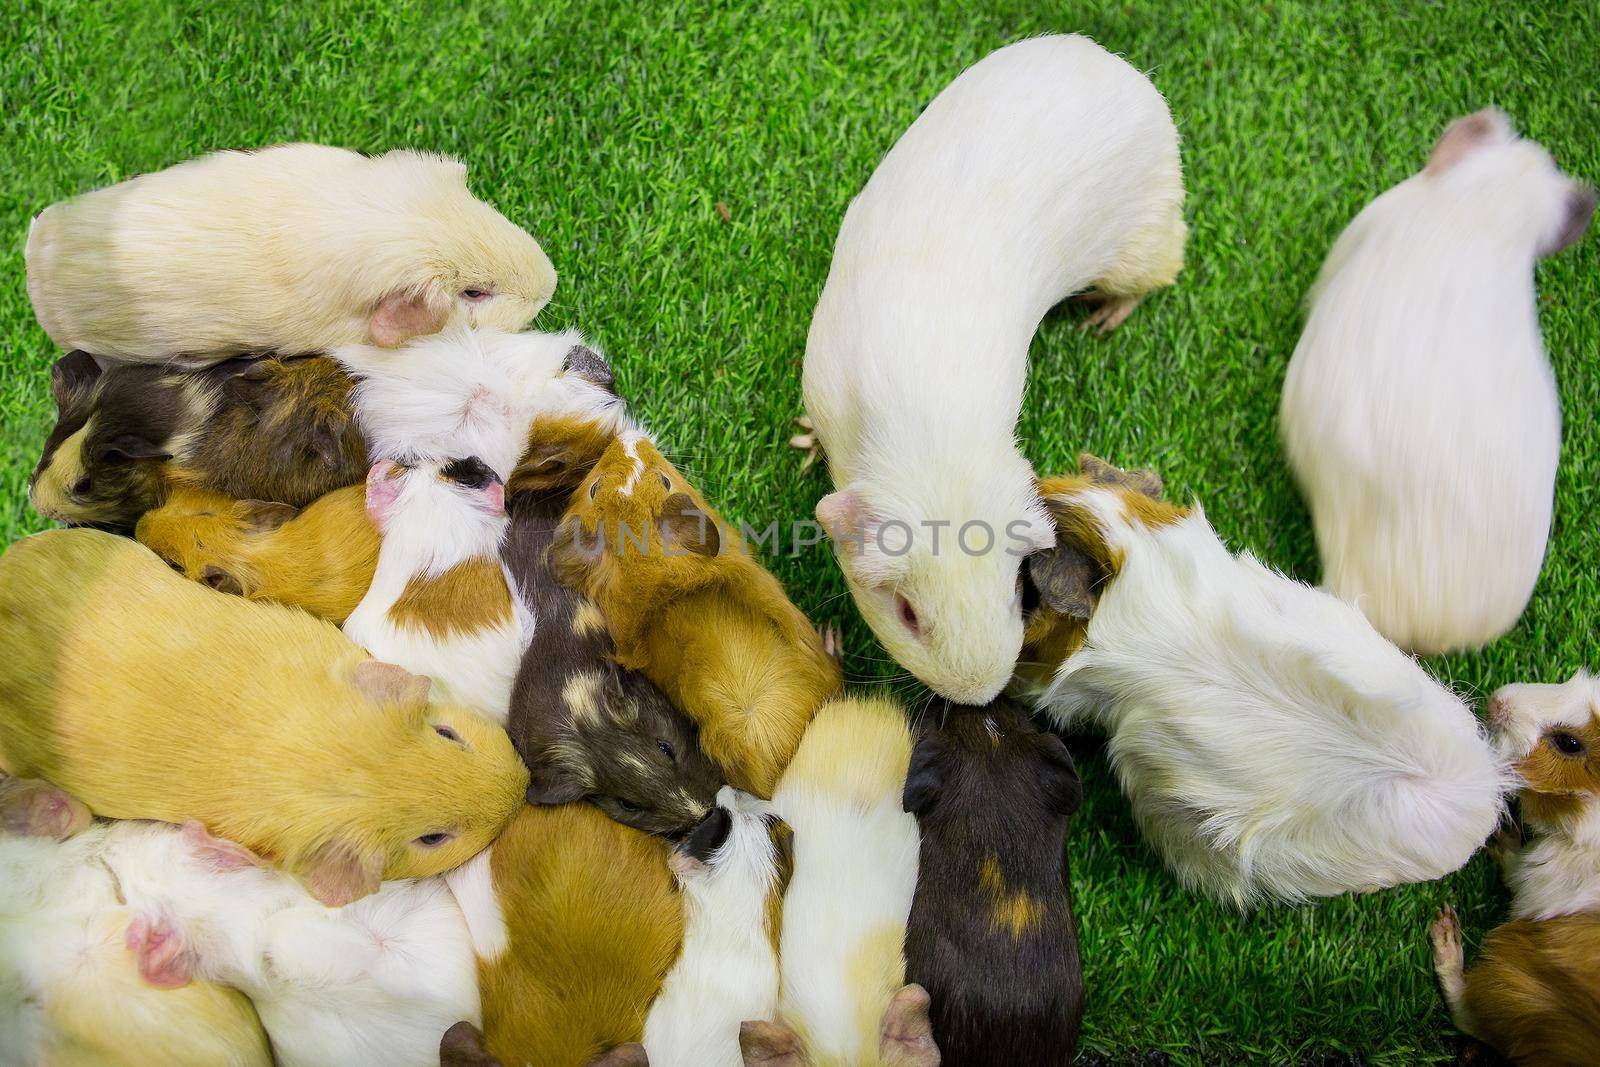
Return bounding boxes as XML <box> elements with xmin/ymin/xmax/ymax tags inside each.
<box><xmin>288</xmin><ymin>659</ymin><xmax>528</xmax><ymax>905</ymax></box>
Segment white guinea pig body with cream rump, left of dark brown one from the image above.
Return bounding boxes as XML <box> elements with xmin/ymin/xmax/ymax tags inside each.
<box><xmin>773</xmin><ymin>702</ymin><xmax>922</xmax><ymax>1064</ymax></box>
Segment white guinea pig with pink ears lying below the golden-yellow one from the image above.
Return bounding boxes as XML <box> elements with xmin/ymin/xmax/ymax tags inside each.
<box><xmin>106</xmin><ymin>822</ymin><xmax>478</xmax><ymax>1067</ymax></box>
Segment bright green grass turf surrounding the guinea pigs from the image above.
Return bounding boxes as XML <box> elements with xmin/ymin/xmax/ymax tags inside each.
<box><xmin>0</xmin><ymin>0</ymin><xmax>1600</xmax><ymax>1064</ymax></box>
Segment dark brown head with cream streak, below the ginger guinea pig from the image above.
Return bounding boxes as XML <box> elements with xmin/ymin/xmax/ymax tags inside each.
<box><xmin>528</xmin><ymin>667</ymin><xmax>725</xmax><ymax>837</ymax></box>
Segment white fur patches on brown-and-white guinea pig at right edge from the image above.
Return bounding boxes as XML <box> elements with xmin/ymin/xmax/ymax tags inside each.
<box><xmin>1490</xmin><ymin>670</ymin><xmax>1600</xmax><ymax>921</ymax></box>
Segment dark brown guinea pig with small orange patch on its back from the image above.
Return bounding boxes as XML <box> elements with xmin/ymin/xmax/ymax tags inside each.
<box><xmin>904</xmin><ymin>697</ymin><xmax>1083</xmax><ymax>1067</ymax></box>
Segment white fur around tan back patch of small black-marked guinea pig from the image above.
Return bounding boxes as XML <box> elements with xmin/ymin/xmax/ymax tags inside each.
<box><xmin>342</xmin><ymin>464</ymin><xmax>533</xmax><ymax>726</ymax></box>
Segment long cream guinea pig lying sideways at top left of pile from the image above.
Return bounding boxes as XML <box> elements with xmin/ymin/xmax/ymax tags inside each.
<box><xmin>24</xmin><ymin>144</ymin><xmax>555</xmax><ymax>363</ymax></box>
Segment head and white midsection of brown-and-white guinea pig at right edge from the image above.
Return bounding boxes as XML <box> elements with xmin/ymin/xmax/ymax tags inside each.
<box><xmin>1488</xmin><ymin>670</ymin><xmax>1600</xmax><ymax>920</ymax></box>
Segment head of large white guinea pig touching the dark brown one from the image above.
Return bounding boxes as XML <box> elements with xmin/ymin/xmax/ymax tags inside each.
<box><xmin>816</xmin><ymin>456</ymin><xmax>1054</xmax><ymax>704</ymax></box>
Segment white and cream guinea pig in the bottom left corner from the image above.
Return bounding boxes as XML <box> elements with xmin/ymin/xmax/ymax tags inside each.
<box><xmin>0</xmin><ymin>812</ymin><xmax>274</xmax><ymax>1067</ymax></box>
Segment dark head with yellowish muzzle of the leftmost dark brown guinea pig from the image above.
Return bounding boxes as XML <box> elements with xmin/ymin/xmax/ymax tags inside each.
<box><xmin>27</xmin><ymin>352</ymin><xmax>170</xmax><ymax>530</ymax></box>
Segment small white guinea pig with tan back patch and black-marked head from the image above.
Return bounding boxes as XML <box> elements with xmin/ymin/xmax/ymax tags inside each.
<box><xmin>344</xmin><ymin>456</ymin><xmax>533</xmax><ymax>725</ymax></box>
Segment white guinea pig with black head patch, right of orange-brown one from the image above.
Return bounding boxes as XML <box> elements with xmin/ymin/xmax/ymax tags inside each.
<box><xmin>645</xmin><ymin>785</ymin><xmax>794</xmax><ymax>1067</ymax></box>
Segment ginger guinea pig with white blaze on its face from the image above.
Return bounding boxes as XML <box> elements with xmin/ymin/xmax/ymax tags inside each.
<box><xmin>550</xmin><ymin>432</ymin><xmax>842</xmax><ymax>797</ymax></box>
